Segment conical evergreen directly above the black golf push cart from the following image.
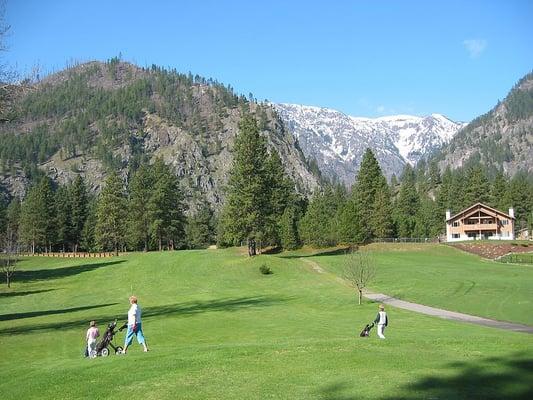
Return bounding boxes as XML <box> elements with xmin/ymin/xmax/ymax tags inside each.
<box><xmin>95</xmin><ymin>172</ymin><xmax>126</xmax><ymax>255</ymax></box>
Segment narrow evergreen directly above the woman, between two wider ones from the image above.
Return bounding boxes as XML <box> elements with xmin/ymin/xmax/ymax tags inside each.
<box><xmin>127</xmin><ymin>164</ymin><xmax>153</xmax><ymax>251</ymax></box>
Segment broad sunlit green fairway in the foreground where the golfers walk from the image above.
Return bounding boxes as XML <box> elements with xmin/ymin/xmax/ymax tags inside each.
<box><xmin>0</xmin><ymin>248</ymin><xmax>533</xmax><ymax>400</ymax></box>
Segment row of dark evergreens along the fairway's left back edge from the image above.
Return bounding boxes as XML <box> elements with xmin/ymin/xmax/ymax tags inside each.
<box><xmin>0</xmin><ymin>159</ymin><xmax>215</xmax><ymax>253</ymax></box>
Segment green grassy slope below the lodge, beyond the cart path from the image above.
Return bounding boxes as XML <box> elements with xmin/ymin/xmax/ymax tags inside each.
<box><xmin>290</xmin><ymin>244</ymin><xmax>533</xmax><ymax>325</ymax></box>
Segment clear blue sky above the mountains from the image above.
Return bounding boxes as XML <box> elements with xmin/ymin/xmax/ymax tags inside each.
<box><xmin>5</xmin><ymin>0</ymin><xmax>533</xmax><ymax>121</ymax></box>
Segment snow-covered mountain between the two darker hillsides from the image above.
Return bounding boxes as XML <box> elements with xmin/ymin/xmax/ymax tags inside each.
<box><xmin>273</xmin><ymin>104</ymin><xmax>464</xmax><ymax>185</ymax></box>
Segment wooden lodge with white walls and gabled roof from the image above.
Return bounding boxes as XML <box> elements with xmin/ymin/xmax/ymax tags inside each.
<box><xmin>446</xmin><ymin>203</ymin><xmax>515</xmax><ymax>242</ymax></box>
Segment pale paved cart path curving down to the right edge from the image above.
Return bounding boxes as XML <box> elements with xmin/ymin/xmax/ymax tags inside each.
<box><xmin>300</xmin><ymin>258</ymin><xmax>533</xmax><ymax>334</ymax></box>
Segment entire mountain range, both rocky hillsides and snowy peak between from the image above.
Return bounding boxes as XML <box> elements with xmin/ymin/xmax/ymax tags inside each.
<box><xmin>0</xmin><ymin>59</ymin><xmax>533</xmax><ymax>209</ymax></box>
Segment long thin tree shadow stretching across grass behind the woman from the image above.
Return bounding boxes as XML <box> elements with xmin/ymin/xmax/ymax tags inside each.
<box><xmin>0</xmin><ymin>296</ymin><xmax>290</xmax><ymax>335</ymax></box>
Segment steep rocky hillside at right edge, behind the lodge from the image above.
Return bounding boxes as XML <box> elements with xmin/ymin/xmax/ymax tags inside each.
<box><xmin>437</xmin><ymin>72</ymin><xmax>533</xmax><ymax>175</ymax></box>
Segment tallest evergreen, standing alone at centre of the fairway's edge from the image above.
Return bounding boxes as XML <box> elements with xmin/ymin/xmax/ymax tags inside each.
<box><xmin>218</xmin><ymin>114</ymin><xmax>271</xmax><ymax>255</ymax></box>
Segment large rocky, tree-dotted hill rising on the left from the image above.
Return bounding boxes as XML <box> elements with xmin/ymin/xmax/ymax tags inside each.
<box><xmin>0</xmin><ymin>59</ymin><xmax>318</xmax><ymax>207</ymax></box>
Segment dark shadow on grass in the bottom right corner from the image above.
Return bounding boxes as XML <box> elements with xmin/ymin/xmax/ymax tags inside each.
<box><xmin>319</xmin><ymin>353</ymin><xmax>533</xmax><ymax>400</ymax></box>
